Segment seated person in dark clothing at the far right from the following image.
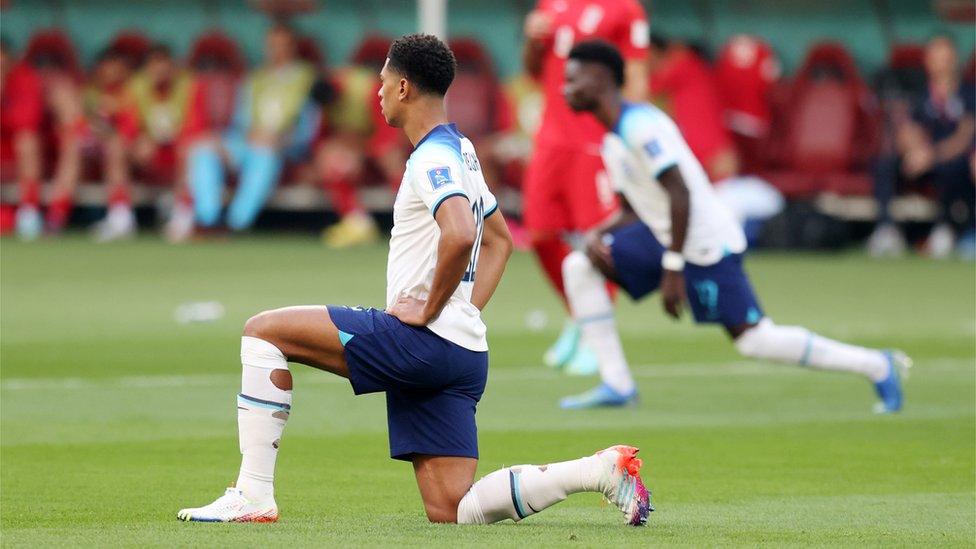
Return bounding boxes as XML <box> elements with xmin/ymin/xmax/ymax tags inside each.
<box><xmin>868</xmin><ymin>36</ymin><xmax>976</xmax><ymax>258</ymax></box>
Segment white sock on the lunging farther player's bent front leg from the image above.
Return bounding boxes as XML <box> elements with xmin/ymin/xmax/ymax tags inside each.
<box><xmin>563</xmin><ymin>251</ymin><xmax>634</xmax><ymax>395</ymax></box>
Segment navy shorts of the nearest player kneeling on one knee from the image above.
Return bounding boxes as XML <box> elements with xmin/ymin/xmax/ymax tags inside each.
<box><xmin>328</xmin><ymin>305</ymin><xmax>488</xmax><ymax>461</ymax></box>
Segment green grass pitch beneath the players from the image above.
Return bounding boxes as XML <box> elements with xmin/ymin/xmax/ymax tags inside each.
<box><xmin>0</xmin><ymin>236</ymin><xmax>976</xmax><ymax>547</ymax></box>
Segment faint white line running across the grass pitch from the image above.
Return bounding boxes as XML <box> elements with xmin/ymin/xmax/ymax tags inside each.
<box><xmin>0</xmin><ymin>358</ymin><xmax>976</xmax><ymax>391</ymax></box>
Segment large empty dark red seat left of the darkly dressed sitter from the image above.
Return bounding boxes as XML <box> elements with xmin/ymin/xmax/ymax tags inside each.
<box><xmin>763</xmin><ymin>43</ymin><xmax>878</xmax><ymax>197</ymax></box>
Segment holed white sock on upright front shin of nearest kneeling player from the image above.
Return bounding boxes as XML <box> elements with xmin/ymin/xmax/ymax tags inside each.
<box><xmin>237</xmin><ymin>336</ymin><xmax>291</xmax><ymax>501</ymax></box>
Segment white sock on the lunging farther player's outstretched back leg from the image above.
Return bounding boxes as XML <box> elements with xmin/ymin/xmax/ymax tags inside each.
<box><xmin>735</xmin><ymin>318</ymin><xmax>888</xmax><ymax>382</ymax></box>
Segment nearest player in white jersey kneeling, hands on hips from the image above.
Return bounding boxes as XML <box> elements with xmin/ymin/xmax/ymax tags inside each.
<box><xmin>177</xmin><ymin>34</ymin><xmax>651</xmax><ymax>525</ymax></box>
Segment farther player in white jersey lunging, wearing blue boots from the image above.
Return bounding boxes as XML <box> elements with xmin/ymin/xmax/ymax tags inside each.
<box><xmin>560</xmin><ymin>41</ymin><xmax>911</xmax><ymax>413</ymax></box>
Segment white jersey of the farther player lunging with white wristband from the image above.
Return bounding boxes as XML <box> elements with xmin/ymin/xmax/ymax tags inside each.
<box><xmin>601</xmin><ymin>103</ymin><xmax>746</xmax><ymax>265</ymax></box>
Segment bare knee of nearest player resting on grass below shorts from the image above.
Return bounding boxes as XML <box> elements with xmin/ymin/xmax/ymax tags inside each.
<box><xmin>413</xmin><ymin>455</ymin><xmax>478</xmax><ymax>522</ymax></box>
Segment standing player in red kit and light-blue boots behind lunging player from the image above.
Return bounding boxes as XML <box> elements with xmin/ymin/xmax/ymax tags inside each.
<box><xmin>522</xmin><ymin>0</ymin><xmax>649</xmax><ymax>374</ymax></box>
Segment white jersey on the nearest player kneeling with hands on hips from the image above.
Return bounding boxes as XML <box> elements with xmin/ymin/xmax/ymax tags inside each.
<box><xmin>386</xmin><ymin>124</ymin><xmax>498</xmax><ymax>351</ymax></box>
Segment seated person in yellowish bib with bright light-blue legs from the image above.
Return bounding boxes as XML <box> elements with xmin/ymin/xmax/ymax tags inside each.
<box><xmin>187</xmin><ymin>24</ymin><xmax>320</xmax><ymax>231</ymax></box>
